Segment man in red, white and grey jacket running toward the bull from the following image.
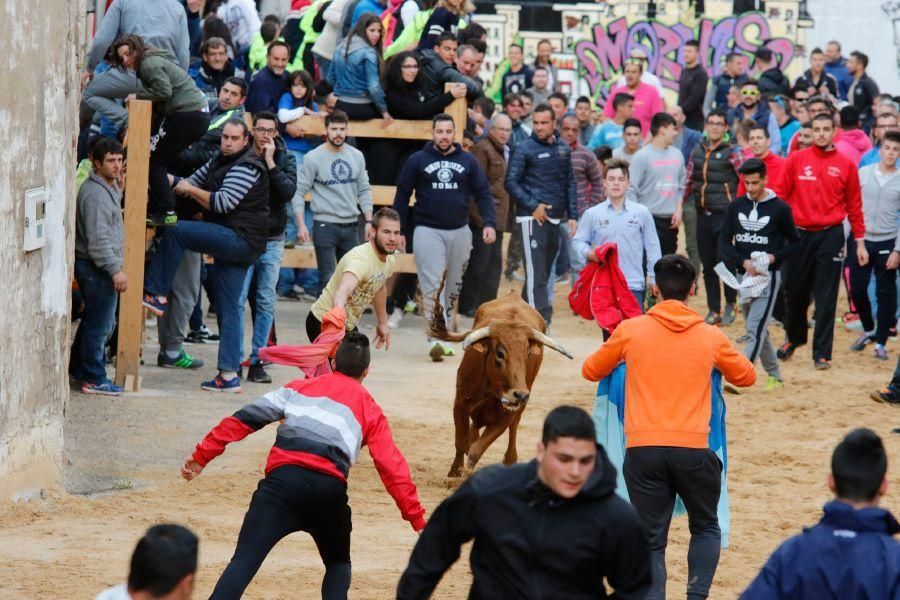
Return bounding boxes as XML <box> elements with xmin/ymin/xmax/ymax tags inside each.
<box><xmin>181</xmin><ymin>332</ymin><xmax>425</xmax><ymax>599</ymax></box>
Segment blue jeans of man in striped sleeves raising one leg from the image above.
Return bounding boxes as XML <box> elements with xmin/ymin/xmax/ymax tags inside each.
<box><xmin>144</xmin><ymin>221</ymin><xmax>259</xmax><ymax>371</ymax></box>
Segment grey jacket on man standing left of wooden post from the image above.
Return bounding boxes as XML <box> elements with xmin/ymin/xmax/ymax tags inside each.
<box><xmin>75</xmin><ymin>170</ymin><xmax>125</xmax><ymax>277</ymax></box>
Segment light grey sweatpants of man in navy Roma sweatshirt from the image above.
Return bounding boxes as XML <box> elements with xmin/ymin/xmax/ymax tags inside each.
<box><xmin>413</xmin><ymin>225</ymin><xmax>472</xmax><ymax>338</ymax></box>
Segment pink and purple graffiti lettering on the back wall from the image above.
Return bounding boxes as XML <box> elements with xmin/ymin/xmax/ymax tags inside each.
<box><xmin>575</xmin><ymin>12</ymin><xmax>796</xmax><ymax>98</ymax></box>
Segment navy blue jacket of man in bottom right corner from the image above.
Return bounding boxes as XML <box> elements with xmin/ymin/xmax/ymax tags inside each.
<box><xmin>741</xmin><ymin>501</ymin><xmax>900</xmax><ymax>600</ymax></box>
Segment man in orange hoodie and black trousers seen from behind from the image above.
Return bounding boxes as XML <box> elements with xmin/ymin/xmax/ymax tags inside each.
<box><xmin>582</xmin><ymin>254</ymin><xmax>756</xmax><ymax>599</ymax></box>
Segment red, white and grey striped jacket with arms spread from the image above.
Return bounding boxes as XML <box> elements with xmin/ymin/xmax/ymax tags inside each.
<box><xmin>193</xmin><ymin>373</ymin><xmax>425</xmax><ymax>531</ymax></box>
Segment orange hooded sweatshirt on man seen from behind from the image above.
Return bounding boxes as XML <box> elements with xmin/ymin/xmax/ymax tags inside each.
<box><xmin>581</xmin><ymin>300</ymin><xmax>756</xmax><ymax>448</ymax></box>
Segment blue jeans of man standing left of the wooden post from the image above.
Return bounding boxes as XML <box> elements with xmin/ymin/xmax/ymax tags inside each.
<box><xmin>69</xmin><ymin>258</ymin><xmax>119</xmax><ymax>384</ymax></box>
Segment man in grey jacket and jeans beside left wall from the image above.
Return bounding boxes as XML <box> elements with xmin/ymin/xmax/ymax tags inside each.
<box><xmin>69</xmin><ymin>138</ymin><xmax>128</xmax><ymax>396</ymax></box>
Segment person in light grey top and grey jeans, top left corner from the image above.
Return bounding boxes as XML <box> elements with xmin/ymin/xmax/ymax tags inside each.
<box><xmin>81</xmin><ymin>0</ymin><xmax>191</xmax><ymax>127</ymax></box>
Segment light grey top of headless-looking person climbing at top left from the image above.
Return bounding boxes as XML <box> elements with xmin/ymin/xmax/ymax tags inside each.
<box><xmin>87</xmin><ymin>0</ymin><xmax>191</xmax><ymax>71</ymax></box>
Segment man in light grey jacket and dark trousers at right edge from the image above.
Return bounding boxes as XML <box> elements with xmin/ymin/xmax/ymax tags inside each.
<box><xmin>846</xmin><ymin>131</ymin><xmax>900</xmax><ymax>360</ymax></box>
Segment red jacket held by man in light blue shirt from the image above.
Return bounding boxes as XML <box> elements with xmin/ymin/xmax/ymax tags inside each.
<box><xmin>569</xmin><ymin>243</ymin><xmax>641</xmax><ymax>332</ymax></box>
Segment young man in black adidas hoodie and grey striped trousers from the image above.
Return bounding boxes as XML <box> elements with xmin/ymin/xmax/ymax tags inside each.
<box><xmin>719</xmin><ymin>158</ymin><xmax>800</xmax><ymax>390</ymax></box>
